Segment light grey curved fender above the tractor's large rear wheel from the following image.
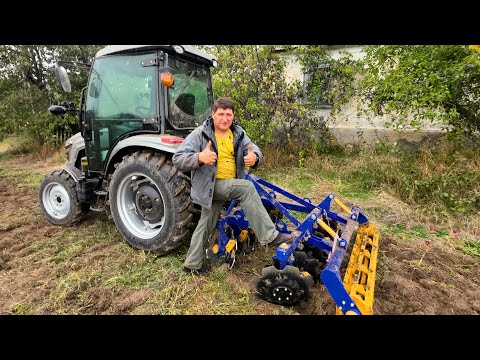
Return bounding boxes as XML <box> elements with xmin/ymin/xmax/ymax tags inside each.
<box><xmin>104</xmin><ymin>134</ymin><xmax>184</xmax><ymax>174</ymax></box>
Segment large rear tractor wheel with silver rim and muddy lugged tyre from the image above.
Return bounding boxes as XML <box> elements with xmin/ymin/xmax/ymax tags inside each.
<box><xmin>108</xmin><ymin>151</ymin><xmax>193</xmax><ymax>255</ymax></box>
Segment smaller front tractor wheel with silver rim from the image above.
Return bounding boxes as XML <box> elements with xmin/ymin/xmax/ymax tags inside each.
<box><xmin>38</xmin><ymin>169</ymin><xmax>82</xmax><ymax>226</ymax></box>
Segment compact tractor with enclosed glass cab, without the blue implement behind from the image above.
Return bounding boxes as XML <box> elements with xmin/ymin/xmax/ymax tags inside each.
<box><xmin>38</xmin><ymin>45</ymin><xmax>217</xmax><ymax>255</ymax></box>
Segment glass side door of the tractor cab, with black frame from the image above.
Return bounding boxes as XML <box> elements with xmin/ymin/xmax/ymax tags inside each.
<box><xmin>83</xmin><ymin>52</ymin><xmax>159</xmax><ymax>172</ymax></box>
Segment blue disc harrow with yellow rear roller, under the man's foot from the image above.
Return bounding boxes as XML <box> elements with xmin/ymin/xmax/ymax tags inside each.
<box><xmin>207</xmin><ymin>173</ymin><xmax>380</xmax><ymax>315</ymax></box>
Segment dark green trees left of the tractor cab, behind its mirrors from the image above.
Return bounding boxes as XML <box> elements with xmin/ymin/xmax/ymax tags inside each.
<box><xmin>0</xmin><ymin>45</ymin><xmax>100</xmax><ymax>145</ymax></box>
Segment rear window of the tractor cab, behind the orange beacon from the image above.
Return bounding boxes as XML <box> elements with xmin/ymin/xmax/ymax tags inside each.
<box><xmin>168</xmin><ymin>58</ymin><xmax>213</xmax><ymax>129</ymax></box>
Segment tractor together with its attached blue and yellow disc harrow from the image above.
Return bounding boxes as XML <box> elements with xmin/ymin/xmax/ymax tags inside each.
<box><xmin>38</xmin><ymin>45</ymin><xmax>379</xmax><ymax>314</ymax></box>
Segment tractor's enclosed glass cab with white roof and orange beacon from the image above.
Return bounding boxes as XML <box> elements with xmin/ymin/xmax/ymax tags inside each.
<box><xmin>51</xmin><ymin>45</ymin><xmax>216</xmax><ymax>173</ymax></box>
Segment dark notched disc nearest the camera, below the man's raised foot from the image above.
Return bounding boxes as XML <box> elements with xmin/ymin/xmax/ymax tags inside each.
<box><xmin>256</xmin><ymin>265</ymin><xmax>314</xmax><ymax>306</ymax></box>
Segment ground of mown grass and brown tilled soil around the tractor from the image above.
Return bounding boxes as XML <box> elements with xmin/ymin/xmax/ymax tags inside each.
<box><xmin>0</xmin><ymin>143</ymin><xmax>480</xmax><ymax>315</ymax></box>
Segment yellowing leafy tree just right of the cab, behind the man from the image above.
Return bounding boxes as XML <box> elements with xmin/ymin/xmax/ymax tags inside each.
<box><xmin>207</xmin><ymin>45</ymin><xmax>326</xmax><ymax>153</ymax></box>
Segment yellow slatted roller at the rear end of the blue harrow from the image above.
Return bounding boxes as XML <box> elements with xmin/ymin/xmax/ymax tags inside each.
<box><xmin>336</xmin><ymin>224</ymin><xmax>380</xmax><ymax>315</ymax></box>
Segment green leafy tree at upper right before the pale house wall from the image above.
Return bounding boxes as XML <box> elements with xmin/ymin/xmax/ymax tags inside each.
<box><xmin>354</xmin><ymin>45</ymin><xmax>480</xmax><ymax>138</ymax></box>
